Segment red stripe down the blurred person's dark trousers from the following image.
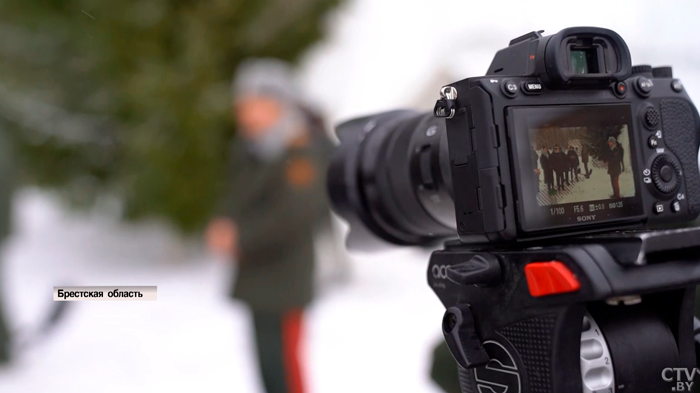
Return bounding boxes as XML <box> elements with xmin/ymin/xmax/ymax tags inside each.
<box><xmin>282</xmin><ymin>310</ymin><xmax>304</xmax><ymax>393</ymax></box>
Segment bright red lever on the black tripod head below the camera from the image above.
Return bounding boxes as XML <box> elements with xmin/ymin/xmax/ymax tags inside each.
<box><xmin>525</xmin><ymin>261</ymin><xmax>581</xmax><ymax>297</ymax></box>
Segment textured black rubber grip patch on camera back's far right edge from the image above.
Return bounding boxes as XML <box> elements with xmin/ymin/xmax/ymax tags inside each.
<box><xmin>660</xmin><ymin>98</ymin><xmax>700</xmax><ymax>215</ymax></box>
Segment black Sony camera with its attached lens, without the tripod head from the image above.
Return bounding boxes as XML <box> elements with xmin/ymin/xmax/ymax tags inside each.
<box><xmin>328</xmin><ymin>27</ymin><xmax>700</xmax><ymax>249</ymax></box>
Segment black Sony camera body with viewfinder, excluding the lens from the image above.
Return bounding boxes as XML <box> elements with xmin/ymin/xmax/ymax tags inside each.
<box><xmin>434</xmin><ymin>27</ymin><xmax>700</xmax><ymax>243</ymax></box>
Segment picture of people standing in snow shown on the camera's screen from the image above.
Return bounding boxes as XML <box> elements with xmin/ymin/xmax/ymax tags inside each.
<box><xmin>529</xmin><ymin>124</ymin><xmax>635</xmax><ymax>206</ymax></box>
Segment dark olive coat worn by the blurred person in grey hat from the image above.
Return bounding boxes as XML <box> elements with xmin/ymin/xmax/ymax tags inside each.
<box><xmin>223</xmin><ymin>133</ymin><xmax>330</xmax><ymax>312</ymax></box>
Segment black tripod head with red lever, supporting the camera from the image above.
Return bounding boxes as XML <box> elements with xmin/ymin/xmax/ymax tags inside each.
<box><xmin>428</xmin><ymin>228</ymin><xmax>700</xmax><ymax>393</ymax></box>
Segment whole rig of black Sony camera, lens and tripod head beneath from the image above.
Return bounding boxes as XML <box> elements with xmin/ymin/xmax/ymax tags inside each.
<box><xmin>328</xmin><ymin>27</ymin><xmax>700</xmax><ymax>393</ymax></box>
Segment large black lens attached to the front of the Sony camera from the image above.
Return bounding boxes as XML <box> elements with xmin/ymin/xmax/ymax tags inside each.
<box><xmin>328</xmin><ymin>111</ymin><xmax>456</xmax><ymax>249</ymax></box>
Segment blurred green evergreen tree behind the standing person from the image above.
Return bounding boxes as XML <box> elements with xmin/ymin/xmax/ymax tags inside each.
<box><xmin>0</xmin><ymin>0</ymin><xmax>339</xmax><ymax>231</ymax></box>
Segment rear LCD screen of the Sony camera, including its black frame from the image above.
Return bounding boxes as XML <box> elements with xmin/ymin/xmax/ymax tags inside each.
<box><xmin>509</xmin><ymin>105</ymin><xmax>643</xmax><ymax>230</ymax></box>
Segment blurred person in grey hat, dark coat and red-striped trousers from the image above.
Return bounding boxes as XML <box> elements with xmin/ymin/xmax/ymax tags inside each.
<box><xmin>206</xmin><ymin>59</ymin><xmax>330</xmax><ymax>393</ymax></box>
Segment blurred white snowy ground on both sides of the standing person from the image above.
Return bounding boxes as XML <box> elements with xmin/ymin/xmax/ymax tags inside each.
<box><xmin>0</xmin><ymin>190</ymin><xmax>443</xmax><ymax>393</ymax></box>
